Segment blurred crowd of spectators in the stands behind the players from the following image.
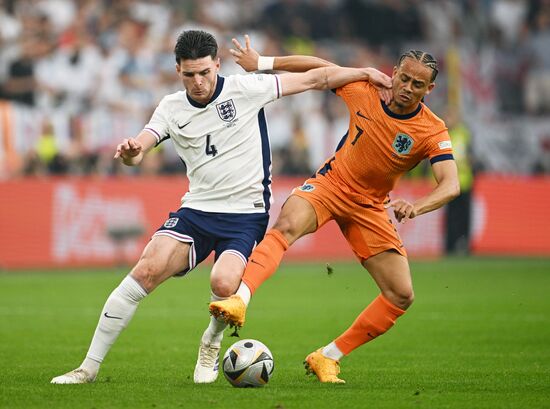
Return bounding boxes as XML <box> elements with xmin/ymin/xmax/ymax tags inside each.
<box><xmin>0</xmin><ymin>0</ymin><xmax>550</xmax><ymax>178</ymax></box>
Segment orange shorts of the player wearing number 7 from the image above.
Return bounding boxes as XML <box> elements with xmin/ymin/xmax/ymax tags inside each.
<box><xmin>292</xmin><ymin>174</ymin><xmax>407</xmax><ymax>261</ymax></box>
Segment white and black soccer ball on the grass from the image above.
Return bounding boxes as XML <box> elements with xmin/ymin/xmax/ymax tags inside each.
<box><xmin>222</xmin><ymin>339</ymin><xmax>275</xmax><ymax>388</ymax></box>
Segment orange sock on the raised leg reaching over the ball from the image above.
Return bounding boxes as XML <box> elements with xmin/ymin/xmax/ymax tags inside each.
<box><xmin>242</xmin><ymin>229</ymin><xmax>288</xmax><ymax>294</ymax></box>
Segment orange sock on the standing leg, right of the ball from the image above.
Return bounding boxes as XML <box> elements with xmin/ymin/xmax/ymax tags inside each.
<box><xmin>334</xmin><ymin>294</ymin><xmax>405</xmax><ymax>355</ymax></box>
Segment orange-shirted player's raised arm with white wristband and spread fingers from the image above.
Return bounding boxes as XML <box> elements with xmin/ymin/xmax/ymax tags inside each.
<box><xmin>229</xmin><ymin>34</ymin><xmax>336</xmax><ymax>72</ymax></box>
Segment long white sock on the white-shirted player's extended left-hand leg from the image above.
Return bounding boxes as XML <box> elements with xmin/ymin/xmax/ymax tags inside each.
<box><xmin>80</xmin><ymin>275</ymin><xmax>147</xmax><ymax>375</ymax></box>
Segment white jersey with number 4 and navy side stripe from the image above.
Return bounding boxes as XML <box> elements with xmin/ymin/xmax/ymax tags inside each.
<box><xmin>145</xmin><ymin>74</ymin><xmax>281</xmax><ymax>213</ymax></box>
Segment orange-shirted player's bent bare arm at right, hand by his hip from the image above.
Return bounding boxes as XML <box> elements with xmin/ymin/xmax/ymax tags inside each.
<box><xmin>385</xmin><ymin>160</ymin><xmax>460</xmax><ymax>223</ymax></box>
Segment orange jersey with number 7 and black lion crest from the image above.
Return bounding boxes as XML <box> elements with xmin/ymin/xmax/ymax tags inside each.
<box><xmin>318</xmin><ymin>82</ymin><xmax>453</xmax><ymax>204</ymax></box>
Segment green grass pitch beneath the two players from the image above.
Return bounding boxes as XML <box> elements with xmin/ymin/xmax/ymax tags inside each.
<box><xmin>0</xmin><ymin>258</ymin><xmax>550</xmax><ymax>409</ymax></box>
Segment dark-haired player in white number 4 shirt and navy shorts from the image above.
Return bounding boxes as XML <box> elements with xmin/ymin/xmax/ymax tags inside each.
<box><xmin>51</xmin><ymin>30</ymin><xmax>391</xmax><ymax>384</ymax></box>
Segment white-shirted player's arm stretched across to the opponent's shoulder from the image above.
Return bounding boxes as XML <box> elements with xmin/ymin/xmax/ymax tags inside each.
<box><xmin>279</xmin><ymin>66</ymin><xmax>391</xmax><ymax>96</ymax></box>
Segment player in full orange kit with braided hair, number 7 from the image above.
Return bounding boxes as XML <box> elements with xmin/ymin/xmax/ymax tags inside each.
<box><xmin>210</xmin><ymin>37</ymin><xmax>460</xmax><ymax>383</ymax></box>
